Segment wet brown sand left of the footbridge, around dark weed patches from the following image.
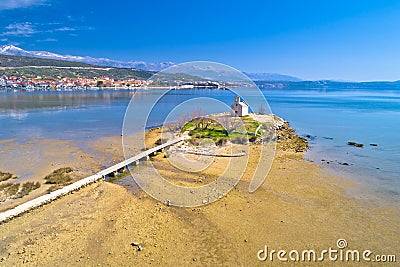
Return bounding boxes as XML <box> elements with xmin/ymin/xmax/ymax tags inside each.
<box><xmin>0</xmin><ymin>138</ymin><xmax>105</xmax><ymax>211</ymax></box>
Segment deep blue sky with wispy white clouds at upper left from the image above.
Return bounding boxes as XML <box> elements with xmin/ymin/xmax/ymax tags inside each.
<box><xmin>0</xmin><ymin>0</ymin><xmax>400</xmax><ymax>81</ymax></box>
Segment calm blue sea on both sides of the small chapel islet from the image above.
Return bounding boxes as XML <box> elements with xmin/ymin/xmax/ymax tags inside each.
<box><xmin>0</xmin><ymin>89</ymin><xmax>400</xmax><ymax>203</ymax></box>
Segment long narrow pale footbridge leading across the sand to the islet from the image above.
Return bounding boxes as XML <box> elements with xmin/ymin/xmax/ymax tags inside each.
<box><xmin>0</xmin><ymin>136</ymin><xmax>188</xmax><ymax>224</ymax></box>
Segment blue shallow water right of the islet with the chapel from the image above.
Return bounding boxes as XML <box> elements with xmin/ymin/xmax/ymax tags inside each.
<box><xmin>265</xmin><ymin>89</ymin><xmax>400</xmax><ymax>205</ymax></box>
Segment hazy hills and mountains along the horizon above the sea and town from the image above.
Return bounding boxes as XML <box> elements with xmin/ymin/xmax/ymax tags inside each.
<box><xmin>0</xmin><ymin>45</ymin><xmax>400</xmax><ymax>86</ymax></box>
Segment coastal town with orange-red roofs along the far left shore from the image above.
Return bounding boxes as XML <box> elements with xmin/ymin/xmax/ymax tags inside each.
<box><xmin>0</xmin><ymin>75</ymin><xmax>152</xmax><ymax>92</ymax></box>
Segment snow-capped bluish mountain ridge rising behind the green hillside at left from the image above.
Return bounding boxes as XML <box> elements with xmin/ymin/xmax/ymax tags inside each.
<box><xmin>0</xmin><ymin>45</ymin><xmax>174</xmax><ymax>71</ymax></box>
